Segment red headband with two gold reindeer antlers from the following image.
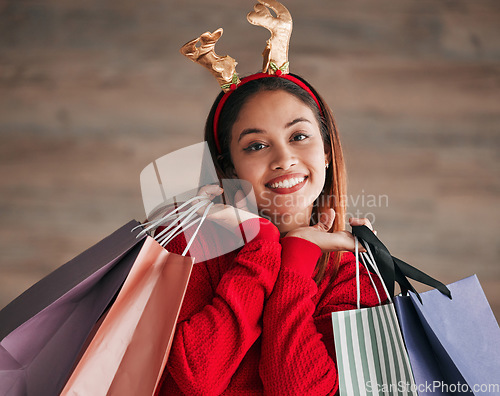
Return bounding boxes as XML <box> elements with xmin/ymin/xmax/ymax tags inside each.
<box><xmin>180</xmin><ymin>0</ymin><xmax>321</xmax><ymax>153</ymax></box>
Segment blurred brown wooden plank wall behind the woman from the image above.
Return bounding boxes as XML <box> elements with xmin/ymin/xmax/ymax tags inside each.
<box><xmin>0</xmin><ymin>0</ymin><xmax>500</xmax><ymax>318</ymax></box>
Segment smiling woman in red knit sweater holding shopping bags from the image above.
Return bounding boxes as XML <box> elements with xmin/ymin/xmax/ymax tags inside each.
<box><xmin>156</xmin><ymin>73</ymin><xmax>386</xmax><ymax>395</ymax></box>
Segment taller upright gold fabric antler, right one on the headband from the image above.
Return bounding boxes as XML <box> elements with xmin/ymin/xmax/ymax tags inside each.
<box><xmin>247</xmin><ymin>0</ymin><xmax>292</xmax><ymax>74</ymax></box>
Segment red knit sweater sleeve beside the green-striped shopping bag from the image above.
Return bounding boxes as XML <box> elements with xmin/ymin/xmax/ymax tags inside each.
<box><xmin>259</xmin><ymin>238</ymin><xmax>384</xmax><ymax>395</ymax></box>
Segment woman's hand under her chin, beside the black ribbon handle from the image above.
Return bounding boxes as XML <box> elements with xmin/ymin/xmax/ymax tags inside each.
<box><xmin>286</xmin><ymin>209</ymin><xmax>371</xmax><ymax>252</ymax></box>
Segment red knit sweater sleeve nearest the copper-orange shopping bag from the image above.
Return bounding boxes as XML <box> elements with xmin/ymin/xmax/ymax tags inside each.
<box><xmin>161</xmin><ymin>219</ymin><xmax>281</xmax><ymax>395</ymax></box>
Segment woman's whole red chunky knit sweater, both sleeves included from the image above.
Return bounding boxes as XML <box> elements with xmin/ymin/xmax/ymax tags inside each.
<box><xmin>159</xmin><ymin>219</ymin><xmax>383</xmax><ymax>395</ymax></box>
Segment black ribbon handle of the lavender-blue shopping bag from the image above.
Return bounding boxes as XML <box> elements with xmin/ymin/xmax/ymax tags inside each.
<box><xmin>352</xmin><ymin>226</ymin><xmax>451</xmax><ymax>303</ymax></box>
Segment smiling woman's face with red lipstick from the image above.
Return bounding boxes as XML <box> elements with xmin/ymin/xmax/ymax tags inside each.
<box><xmin>230</xmin><ymin>90</ymin><xmax>329</xmax><ymax>232</ymax></box>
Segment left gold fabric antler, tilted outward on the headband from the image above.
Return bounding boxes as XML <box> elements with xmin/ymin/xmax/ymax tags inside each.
<box><xmin>180</xmin><ymin>28</ymin><xmax>240</xmax><ymax>92</ymax></box>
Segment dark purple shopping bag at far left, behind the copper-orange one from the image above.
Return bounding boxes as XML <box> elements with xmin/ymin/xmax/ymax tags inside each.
<box><xmin>0</xmin><ymin>221</ymin><xmax>144</xmax><ymax>396</ymax></box>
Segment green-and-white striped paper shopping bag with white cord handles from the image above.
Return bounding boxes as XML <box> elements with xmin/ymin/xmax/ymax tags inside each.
<box><xmin>332</xmin><ymin>238</ymin><xmax>417</xmax><ymax>396</ymax></box>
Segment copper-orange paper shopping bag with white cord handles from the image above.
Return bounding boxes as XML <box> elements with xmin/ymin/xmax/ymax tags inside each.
<box><xmin>61</xmin><ymin>201</ymin><xmax>209</xmax><ymax>396</ymax></box>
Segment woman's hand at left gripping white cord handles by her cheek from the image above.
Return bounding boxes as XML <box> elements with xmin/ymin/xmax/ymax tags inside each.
<box><xmin>193</xmin><ymin>184</ymin><xmax>259</xmax><ymax>232</ymax></box>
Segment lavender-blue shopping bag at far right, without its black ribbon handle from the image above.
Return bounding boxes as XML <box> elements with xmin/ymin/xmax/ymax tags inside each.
<box><xmin>395</xmin><ymin>275</ymin><xmax>500</xmax><ymax>396</ymax></box>
